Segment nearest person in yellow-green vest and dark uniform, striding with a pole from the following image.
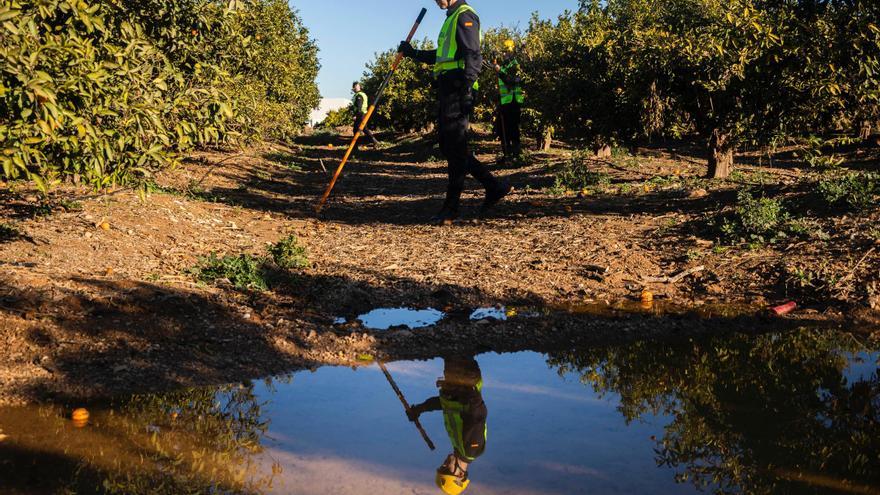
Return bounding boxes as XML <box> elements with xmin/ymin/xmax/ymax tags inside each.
<box><xmin>398</xmin><ymin>0</ymin><xmax>512</xmax><ymax>223</ymax></box>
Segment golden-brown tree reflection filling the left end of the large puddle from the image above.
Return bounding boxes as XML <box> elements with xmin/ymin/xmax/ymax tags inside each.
<box><xmin>0</xmin><ymin>384</ymin><xmax>280</xmax><ymax>495</ymax></box>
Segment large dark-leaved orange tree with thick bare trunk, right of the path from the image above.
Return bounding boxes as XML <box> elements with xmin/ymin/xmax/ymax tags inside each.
<box><xmin>526</xmin><ymin>0</ymin><xmax>878</xmax><ymax>177</ymax></box>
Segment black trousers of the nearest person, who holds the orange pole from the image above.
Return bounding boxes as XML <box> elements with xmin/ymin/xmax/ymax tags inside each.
<box><xmin>437</xmin><ymin>76</ymin><xmax>500</xmax><ymax>209</ymax></box>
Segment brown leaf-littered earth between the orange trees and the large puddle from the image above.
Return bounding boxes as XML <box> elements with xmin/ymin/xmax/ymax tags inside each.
<box><xmin>0</xmin><ymin>134</ymin><xmax>880</xmax><ymax>403</ymax></box>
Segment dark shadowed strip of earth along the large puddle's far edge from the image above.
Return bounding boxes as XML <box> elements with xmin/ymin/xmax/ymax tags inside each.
<box><xmin>0</xmin><ymin>260</ymin><xmax>840</xmax><ymax>406</ymax></box>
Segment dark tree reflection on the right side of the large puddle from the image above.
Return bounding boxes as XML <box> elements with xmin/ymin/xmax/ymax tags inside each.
<box><xmin>548</xmin><ymin>330</ymin><xmax>880</xmax><ymax>493</ymax></box>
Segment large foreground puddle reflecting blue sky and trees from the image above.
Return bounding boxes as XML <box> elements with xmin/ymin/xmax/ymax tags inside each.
<box><xmin>0</xmin><ymin>330</ymin><xmax>880</xmax><ymax>495</ymax></box>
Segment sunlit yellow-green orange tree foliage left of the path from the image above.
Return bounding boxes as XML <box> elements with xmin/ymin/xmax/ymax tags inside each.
<box><xmin>0</xmin><ymin>0</ymin><xmax>318</xmax><ymax>190</ymax></box>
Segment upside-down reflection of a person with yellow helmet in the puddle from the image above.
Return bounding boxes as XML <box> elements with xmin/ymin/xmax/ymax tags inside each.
<box><xmin>408</xmin><ymin>357</ymin><xmax>488</xmax><ymax>495</ymax></box>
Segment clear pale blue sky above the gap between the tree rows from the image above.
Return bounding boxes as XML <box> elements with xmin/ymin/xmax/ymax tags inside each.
<box><xmin>289</xmin><ymin>0</ymin><xmax>578</xmax><ymax>98</ymax></box>
